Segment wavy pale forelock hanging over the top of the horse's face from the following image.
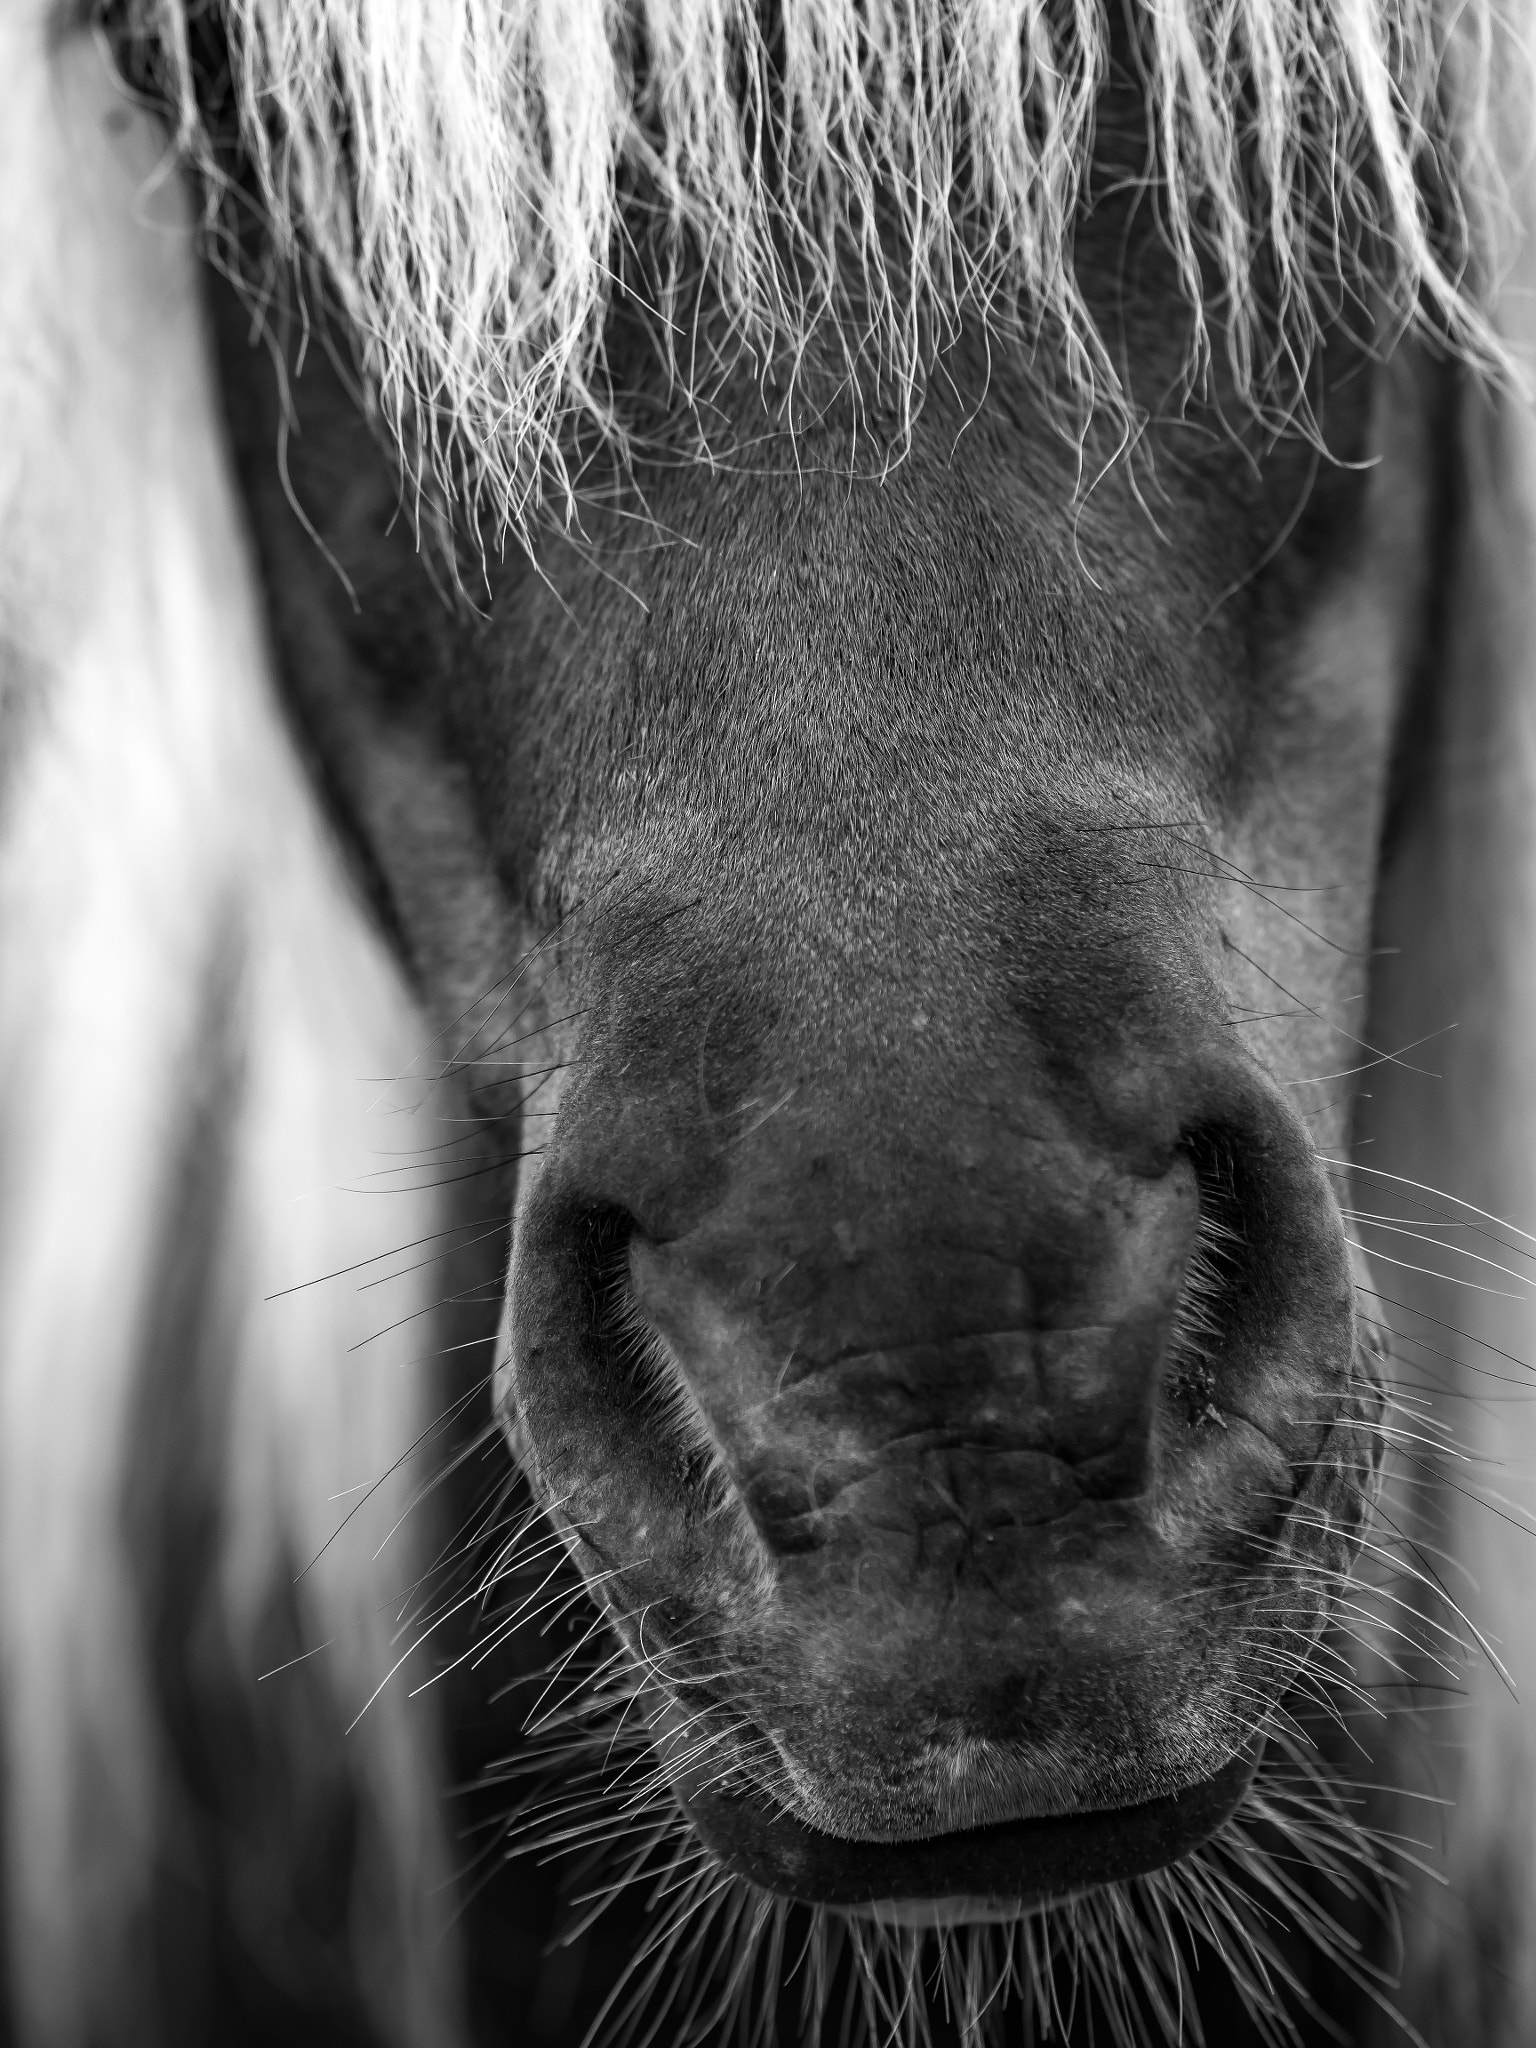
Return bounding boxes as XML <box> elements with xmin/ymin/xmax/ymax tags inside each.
<box><xmin>137</xmin><ymin>0</ymin><xmax>1520</xmax><ymax>528</ymax></box>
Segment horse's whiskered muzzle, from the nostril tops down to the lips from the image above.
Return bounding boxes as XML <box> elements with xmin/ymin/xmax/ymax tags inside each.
<box><xmin>500</xmin><ymin>958</ymin><xmax>1372</xmax><ymax>1913</ymax></box>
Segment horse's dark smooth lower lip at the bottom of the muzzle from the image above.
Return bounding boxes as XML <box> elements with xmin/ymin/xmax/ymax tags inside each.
<box><xmin>676</xmin><ymin>1735</ymin><xmax>1264</xmax><ymax>1925</ymax></box>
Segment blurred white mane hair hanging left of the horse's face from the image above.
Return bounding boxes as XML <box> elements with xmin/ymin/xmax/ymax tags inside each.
<box><xmin>0</xmin><ymin>19</ymin><xmax>453</xmax><ymax>2048</ymax></box>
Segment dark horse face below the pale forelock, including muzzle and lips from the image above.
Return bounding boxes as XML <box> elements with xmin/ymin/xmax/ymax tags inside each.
<box><xmin>237</xmin><ymin>303</ymin><xmax>1434</xmax><ymax>1913</ymax></box>
